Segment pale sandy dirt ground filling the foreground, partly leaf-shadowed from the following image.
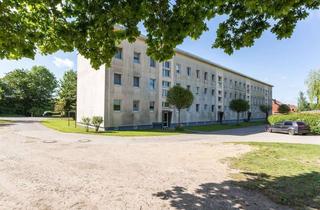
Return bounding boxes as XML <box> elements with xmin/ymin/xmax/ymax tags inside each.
<box><xmin>0</xmin><ymin>121</ymin><xmax>296</xmax><ymax>210</ymax></box>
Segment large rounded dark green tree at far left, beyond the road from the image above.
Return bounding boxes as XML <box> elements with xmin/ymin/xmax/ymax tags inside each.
<box><xmin>2</xmin><ymin>66</ymin><xmax>57</xmax><ymax>116</ymax></box>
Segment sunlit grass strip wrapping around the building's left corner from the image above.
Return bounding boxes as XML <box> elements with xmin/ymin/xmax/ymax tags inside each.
<box><xmin>41</xmin><ymin>119</ymin><xmax>181</xmax><ymax>136</ymax></box>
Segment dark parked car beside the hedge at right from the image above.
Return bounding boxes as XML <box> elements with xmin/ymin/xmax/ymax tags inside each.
<box><xmin>266</xmin><ymin>121</ymin><xmax>310</xmax><ymax>135</ymax></box>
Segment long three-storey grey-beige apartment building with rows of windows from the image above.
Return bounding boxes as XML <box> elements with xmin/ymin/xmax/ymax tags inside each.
<box><xmin>77</xmin><ymin>37</ymin><xmax>272</xmax><ymax>129</ymax></box>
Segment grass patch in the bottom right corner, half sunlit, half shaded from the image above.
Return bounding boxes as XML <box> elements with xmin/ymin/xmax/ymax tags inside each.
<box><xmin>231</xmin><ymin>143</ymin><xmax>320</xmax><ymax>209</ymax></box>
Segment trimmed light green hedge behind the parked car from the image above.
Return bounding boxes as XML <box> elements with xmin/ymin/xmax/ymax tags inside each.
<box><xmin>268</xmin><ymin>113</ymin><xmax>320</xmax><ymax>134</ymax></box>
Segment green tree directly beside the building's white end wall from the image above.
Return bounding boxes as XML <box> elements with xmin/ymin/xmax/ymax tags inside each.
<box><xmin>58</xmin><ymin>70</ymin><xmax>77</xmax><ymax>113</ymax></box>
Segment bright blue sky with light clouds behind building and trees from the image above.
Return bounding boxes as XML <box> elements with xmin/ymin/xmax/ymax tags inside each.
<box><xmin>0</xmin><ymin>11</ymin><xmax>320</xmax><ymax>104</ymax></box>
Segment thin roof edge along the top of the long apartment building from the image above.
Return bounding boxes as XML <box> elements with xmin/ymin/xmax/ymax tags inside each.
<box><xmin>139</xmin><ymin>35</ymin><xmax>273</xmax><ymax>87</ymax></box>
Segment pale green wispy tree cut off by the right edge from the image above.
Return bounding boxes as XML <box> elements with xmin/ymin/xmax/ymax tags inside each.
<box><xmin>305</xmin><ymin>70</ymin><xmax>320</xmax><ymax>108</ymax></box>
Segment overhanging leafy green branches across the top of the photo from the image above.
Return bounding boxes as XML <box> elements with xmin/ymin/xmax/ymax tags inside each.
<box><xmin>0</xmin><ymin>0</ymin><xmax>320</xmax><ymax>68</ymax></box>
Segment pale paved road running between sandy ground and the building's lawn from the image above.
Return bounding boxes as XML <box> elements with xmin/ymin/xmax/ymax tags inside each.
<box><xmin>0</xmin><ymin>118</ymin><xmax>320</xmax><ymax>144</ymax></box>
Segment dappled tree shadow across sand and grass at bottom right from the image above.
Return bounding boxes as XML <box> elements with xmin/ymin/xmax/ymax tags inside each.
<box><xmin>153</xmin><ymin>172</ymin><xmax>320</xmax><ymax>210</ymax></box>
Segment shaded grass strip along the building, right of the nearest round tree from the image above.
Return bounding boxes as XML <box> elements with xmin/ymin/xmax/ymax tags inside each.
<box><xmin>186</xmin><ymin>121</ymin><xmax>265</xmax><ymax>132</ymax></box>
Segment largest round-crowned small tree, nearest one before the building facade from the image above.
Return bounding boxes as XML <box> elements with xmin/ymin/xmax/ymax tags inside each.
<box><xmin>167</xmin><ymin>86</ymin><xmax>193</xmax><ymax>127</ymax></box>
